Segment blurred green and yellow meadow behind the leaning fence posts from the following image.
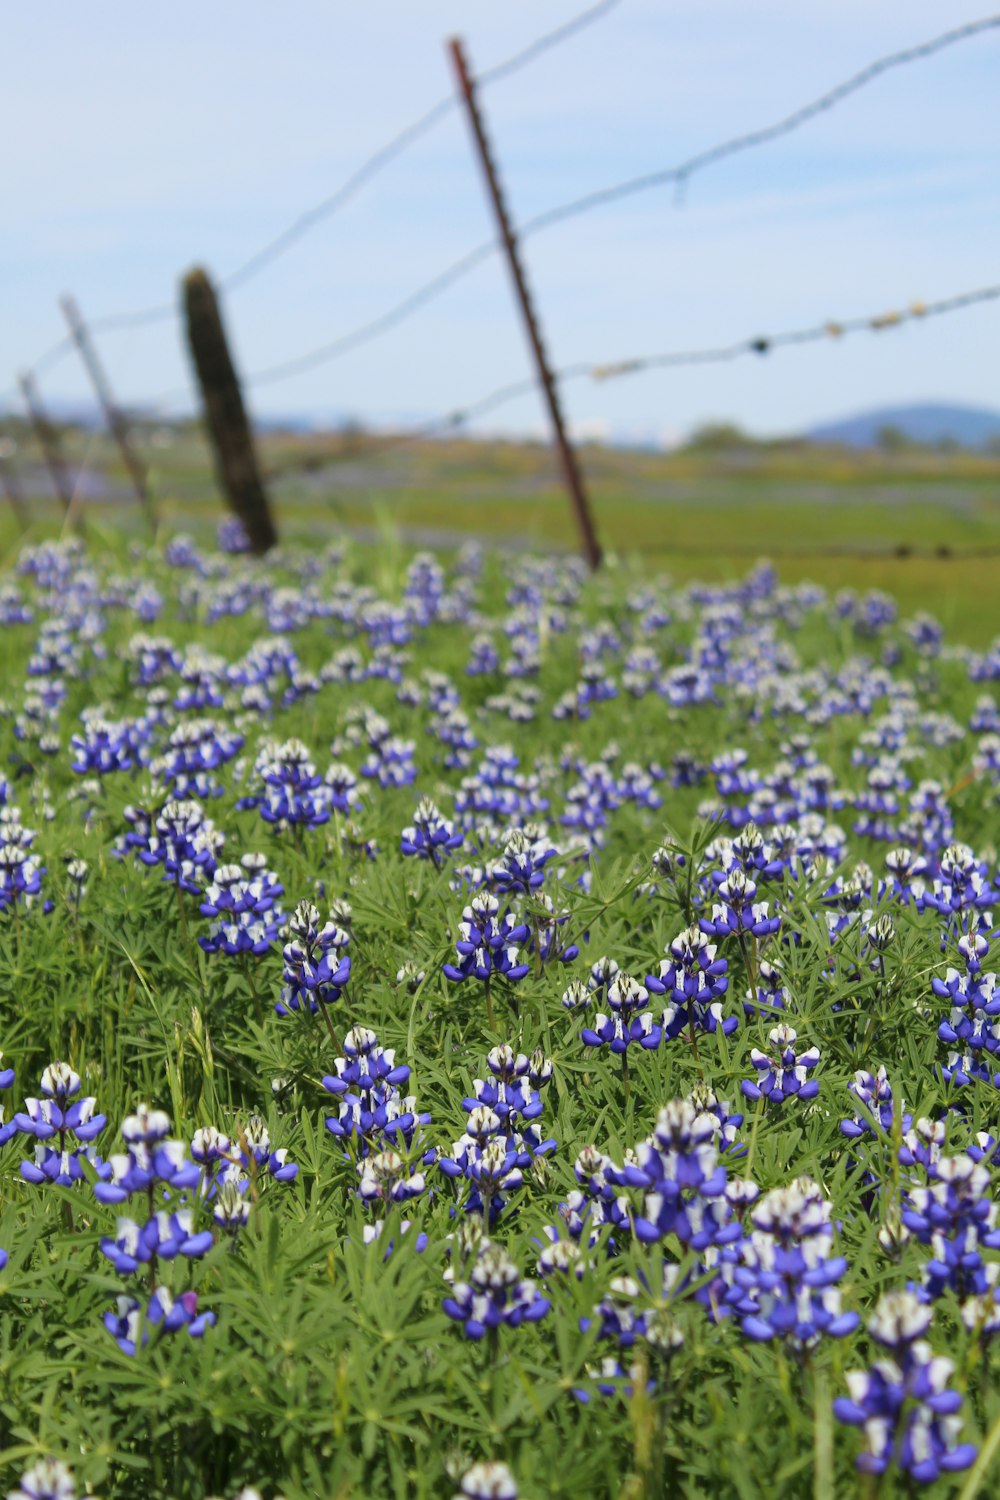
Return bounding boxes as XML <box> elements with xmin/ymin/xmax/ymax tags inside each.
<box><xmin>3</xmin><ymin>425</ymin><xmax>1000</xmax><ymax>647</ymax></box>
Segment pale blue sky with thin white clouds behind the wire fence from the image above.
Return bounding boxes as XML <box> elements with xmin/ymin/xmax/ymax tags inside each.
<box><xmin>0</xmin><ymin>0</ymin><xmax>1000</xmax><ymax>437</ymax></box>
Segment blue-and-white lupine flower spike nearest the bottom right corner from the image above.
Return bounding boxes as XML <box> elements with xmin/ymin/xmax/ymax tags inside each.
<box><xmin>834</xmin><ymin>1292</ymin><xmax>976</xmax><ymax>1485</ymax></box>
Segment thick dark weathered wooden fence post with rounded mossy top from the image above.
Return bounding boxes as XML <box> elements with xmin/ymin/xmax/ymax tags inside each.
<box><xmin>184</xmin><ymin>267</ymin><xmax>277</xmax><ymax>557</ymax></box>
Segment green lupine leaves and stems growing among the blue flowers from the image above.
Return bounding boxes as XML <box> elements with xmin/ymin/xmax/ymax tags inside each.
<box><xmin>0</xmin><ymin>552</ymin><xmax>1000</xmax><ymax>1500</ymax></box>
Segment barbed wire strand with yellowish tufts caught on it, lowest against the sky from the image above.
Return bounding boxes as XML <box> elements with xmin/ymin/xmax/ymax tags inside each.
<box><xmin>268</xmin><ymin>274</ymin><xmax>1000</xmax><ymax>480</ymax></box>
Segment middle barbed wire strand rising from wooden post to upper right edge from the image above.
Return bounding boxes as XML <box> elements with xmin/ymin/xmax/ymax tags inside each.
<box><xmin>232</xmin><ymin>15</ymin><xmax>1000</xmax><ymax>386</ymax></box>
